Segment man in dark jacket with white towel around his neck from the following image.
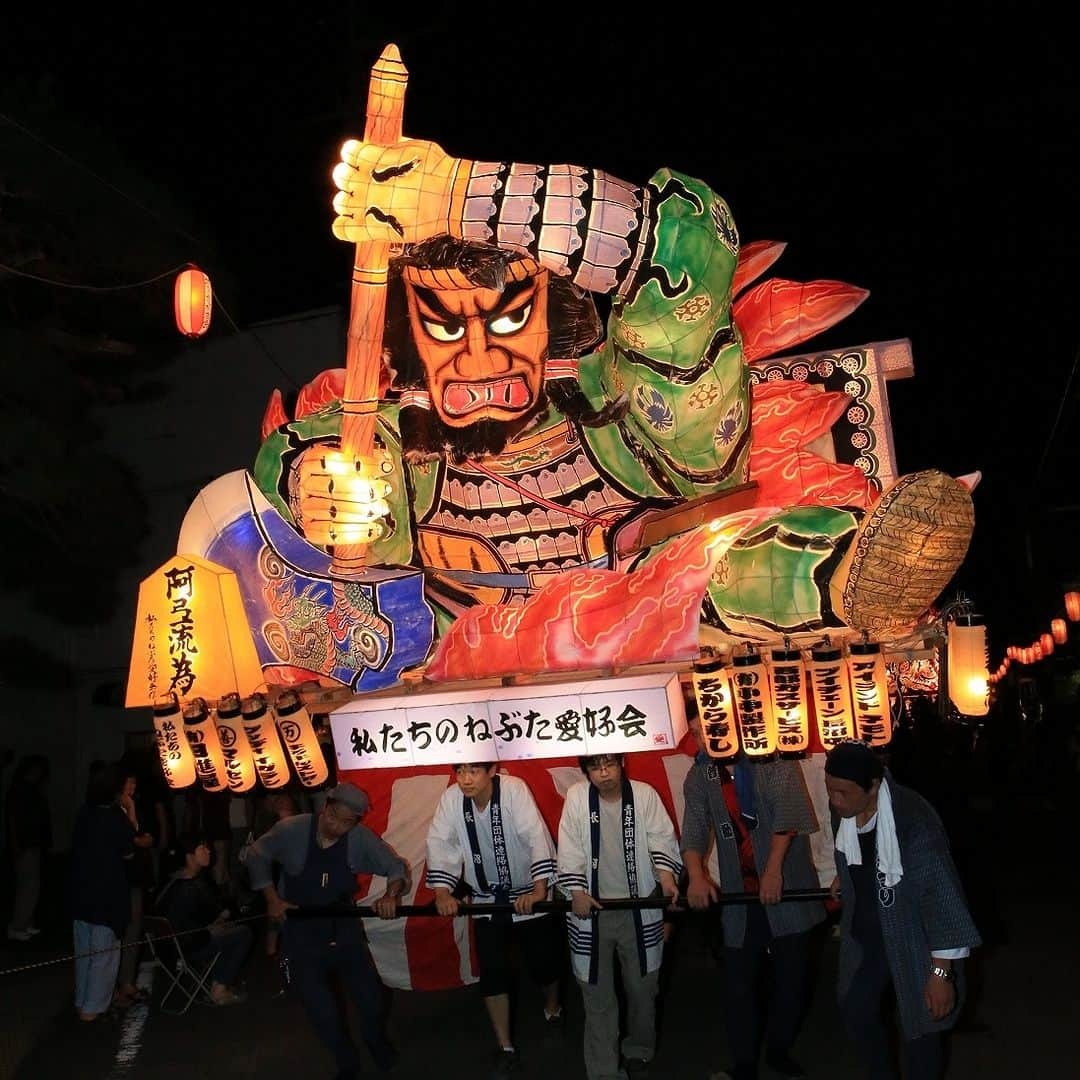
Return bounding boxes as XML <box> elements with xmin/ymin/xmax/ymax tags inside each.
<box><xmin>825</xmin><ymin>741</ymin><xmax>981</xmax><ymax>1080</ymax></box>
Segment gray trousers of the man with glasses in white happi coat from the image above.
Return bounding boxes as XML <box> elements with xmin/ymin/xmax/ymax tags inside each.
<box><xmin>578</xmin><ymin>912</ymin><xmax>660</xmax><ymax>1080</ymax></box>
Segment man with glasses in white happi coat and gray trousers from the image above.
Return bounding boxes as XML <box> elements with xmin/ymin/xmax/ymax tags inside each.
<box><xmin>558</xmin><ymin>754</ymin><xmax>683</xmax><ymax>1080</ymax></box>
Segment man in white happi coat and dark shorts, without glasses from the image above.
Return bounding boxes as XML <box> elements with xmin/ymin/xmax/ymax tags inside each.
<box><xmin>428</xmin><ymin>761</ymin><xmax>563</xmax><ymax>1077</ymax></box>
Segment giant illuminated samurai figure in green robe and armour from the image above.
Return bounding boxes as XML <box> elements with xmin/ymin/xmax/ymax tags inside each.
<box><xmin>243</xmin><ymin>128</ymin><xmax>972</xmax><ymax>673</ymax></box>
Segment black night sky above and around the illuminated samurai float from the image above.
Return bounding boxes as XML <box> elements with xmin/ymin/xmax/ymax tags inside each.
<box><xmin>0</xmin><ymin>3</ymin><xmax>1080</xmax><ymax>661</ymax></box>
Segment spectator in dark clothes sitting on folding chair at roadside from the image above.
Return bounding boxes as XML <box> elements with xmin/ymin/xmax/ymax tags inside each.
<box><xmin>158</xmin><ymin>833</ymin><xmax>252</xmax><ymax>1005</ymax></box>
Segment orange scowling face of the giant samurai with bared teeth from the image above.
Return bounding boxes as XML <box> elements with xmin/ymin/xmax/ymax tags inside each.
<box><xmin>405</xmin><ymin>270</ymin><xmax>548</xmax><ymax>428</ymax></box>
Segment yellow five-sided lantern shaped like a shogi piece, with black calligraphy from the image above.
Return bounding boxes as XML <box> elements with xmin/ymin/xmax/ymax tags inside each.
<box><xmin>125</xmin><ymin>555</ymin><xmax>264</xmax><ymax>708</ymax></box>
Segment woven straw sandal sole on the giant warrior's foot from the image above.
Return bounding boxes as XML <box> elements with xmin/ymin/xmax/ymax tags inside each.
<box><xmin>832</xmin><ymin>470</ymin><xmax>975</xmax><ymax>633</ymax></box>
